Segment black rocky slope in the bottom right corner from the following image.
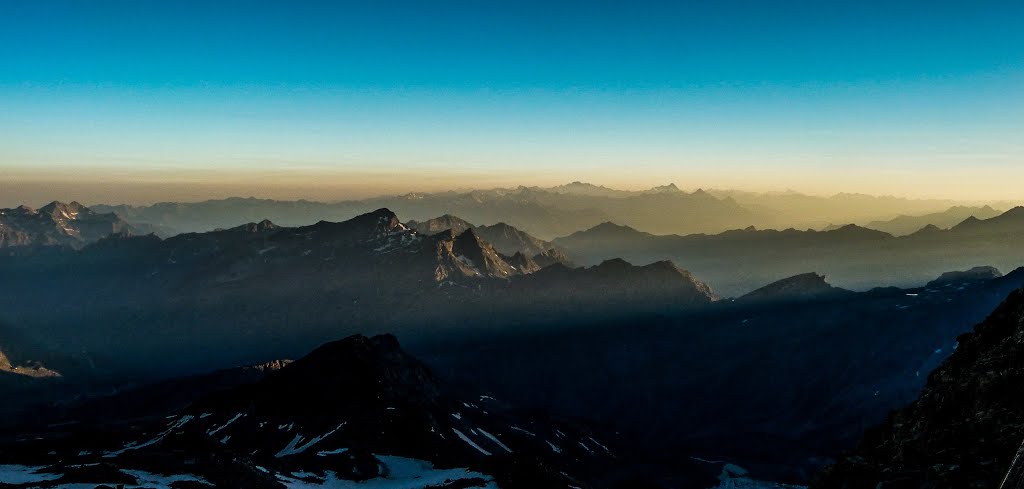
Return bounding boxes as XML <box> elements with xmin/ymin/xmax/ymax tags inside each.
<box><xmin>812</xmin><ymin>291</ymin><xmax>1024</xmax><ymax>489</ymax></box>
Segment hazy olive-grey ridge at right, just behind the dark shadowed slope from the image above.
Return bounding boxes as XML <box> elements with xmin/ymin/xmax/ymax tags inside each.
<box><xmin>553</xmin><ymin>208</ymin><xmax>1024</xmax><ymax>297</ymax></box>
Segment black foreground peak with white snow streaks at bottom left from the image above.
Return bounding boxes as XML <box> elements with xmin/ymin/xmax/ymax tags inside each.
<box><xmin>0</xmin><ymin>336</ymin><xmax>614</xmax><ymax>489</ymax></box>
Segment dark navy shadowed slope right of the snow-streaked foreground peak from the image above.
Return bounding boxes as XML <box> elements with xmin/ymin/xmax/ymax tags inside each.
<box><xmin>416</xmin><ymin>269</ymin><xmax>1024</xmax><ymax>487</ymax></box>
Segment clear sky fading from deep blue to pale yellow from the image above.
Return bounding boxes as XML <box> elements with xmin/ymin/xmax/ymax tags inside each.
<box><xmin>0</xmin><ymin>0</ymin><xmax>1024</xmax><ymax>205</ymax></box>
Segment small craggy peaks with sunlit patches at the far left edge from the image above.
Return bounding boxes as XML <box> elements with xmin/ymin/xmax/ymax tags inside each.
<box><xmin>0</xmin><ymin>202</ymin><xmax>135</xmax><ymax>248</ymax></box>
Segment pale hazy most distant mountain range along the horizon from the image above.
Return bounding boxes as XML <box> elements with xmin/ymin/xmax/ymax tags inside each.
<box><xmin>83</xmin><ymin>182</ymin><xmax>1013</xmax><ymax>240</ymax></box>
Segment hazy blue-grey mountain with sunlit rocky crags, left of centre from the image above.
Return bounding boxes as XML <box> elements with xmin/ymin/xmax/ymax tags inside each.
<box><xmin>0</xmin><ymin>209</ymin><xmax>715</xmax><ymax>382</ymax></box>
